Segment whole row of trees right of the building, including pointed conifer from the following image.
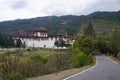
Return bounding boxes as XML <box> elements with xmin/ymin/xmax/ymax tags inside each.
<box><xmin>77</xmin><ymin>18</ymin><xmax>120</xmax><ymax>59</ymax></box>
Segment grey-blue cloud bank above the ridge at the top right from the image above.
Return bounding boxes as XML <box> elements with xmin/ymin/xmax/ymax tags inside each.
<box><xmin>82</xmin><ymin>0</ymin><xmax>120</xmax><ymax>14</ymax></box>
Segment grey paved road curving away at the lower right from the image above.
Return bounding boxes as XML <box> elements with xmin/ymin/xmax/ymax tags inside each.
<box><xmin>64</xmin><ymin>55</ymin><xmax>120</xmax><ymax>80</ymax></box>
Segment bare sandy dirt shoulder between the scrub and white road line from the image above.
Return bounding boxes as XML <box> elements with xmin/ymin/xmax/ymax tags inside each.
<box><xmin>26</xmin><ymin>57</ymin><xmax>96</xmax><ymax>80</ymax></box>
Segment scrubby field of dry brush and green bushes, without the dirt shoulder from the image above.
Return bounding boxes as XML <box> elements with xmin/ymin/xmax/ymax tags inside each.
<box><xmin>0</xmin><ymin>50</ymin><xmax>92</xmax><ymax>80</ymax></box>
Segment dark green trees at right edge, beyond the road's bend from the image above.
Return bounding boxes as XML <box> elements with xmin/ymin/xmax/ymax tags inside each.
<box><xmin>95</xmin><ymin>27</ymin><xmax>120</xmax><ymax>59</ymax></box>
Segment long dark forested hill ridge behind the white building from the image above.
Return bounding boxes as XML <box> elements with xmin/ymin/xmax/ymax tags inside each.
<box><xmin>0</xmin><ymin>11</ymin><xmax>120</xmax><ymax>35</ymax></box>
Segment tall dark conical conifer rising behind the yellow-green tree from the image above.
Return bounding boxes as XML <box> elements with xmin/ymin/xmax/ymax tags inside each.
<box><xmin>84</xmin><ymin>22</ymin><xmax>96</xmax><ymax>38</ymax></box>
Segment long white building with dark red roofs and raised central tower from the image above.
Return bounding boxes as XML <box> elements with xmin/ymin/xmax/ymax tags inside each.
<box><xmin>13</xmin><ymin>28</ymin><xmax>70</xmax><ymax>48</ymax></box>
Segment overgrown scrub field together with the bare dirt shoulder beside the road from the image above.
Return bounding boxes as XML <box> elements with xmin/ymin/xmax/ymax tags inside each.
<box><xmin>0</xmin><ymin>49</ymin><xmax>95</xmax><ymax>80</ymax></box>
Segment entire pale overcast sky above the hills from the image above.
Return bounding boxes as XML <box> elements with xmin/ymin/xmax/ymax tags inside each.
<box><xmin>0</xmin><ymin>0</ymin><xmax>120</xmax><ymax>21</ymax></box>
